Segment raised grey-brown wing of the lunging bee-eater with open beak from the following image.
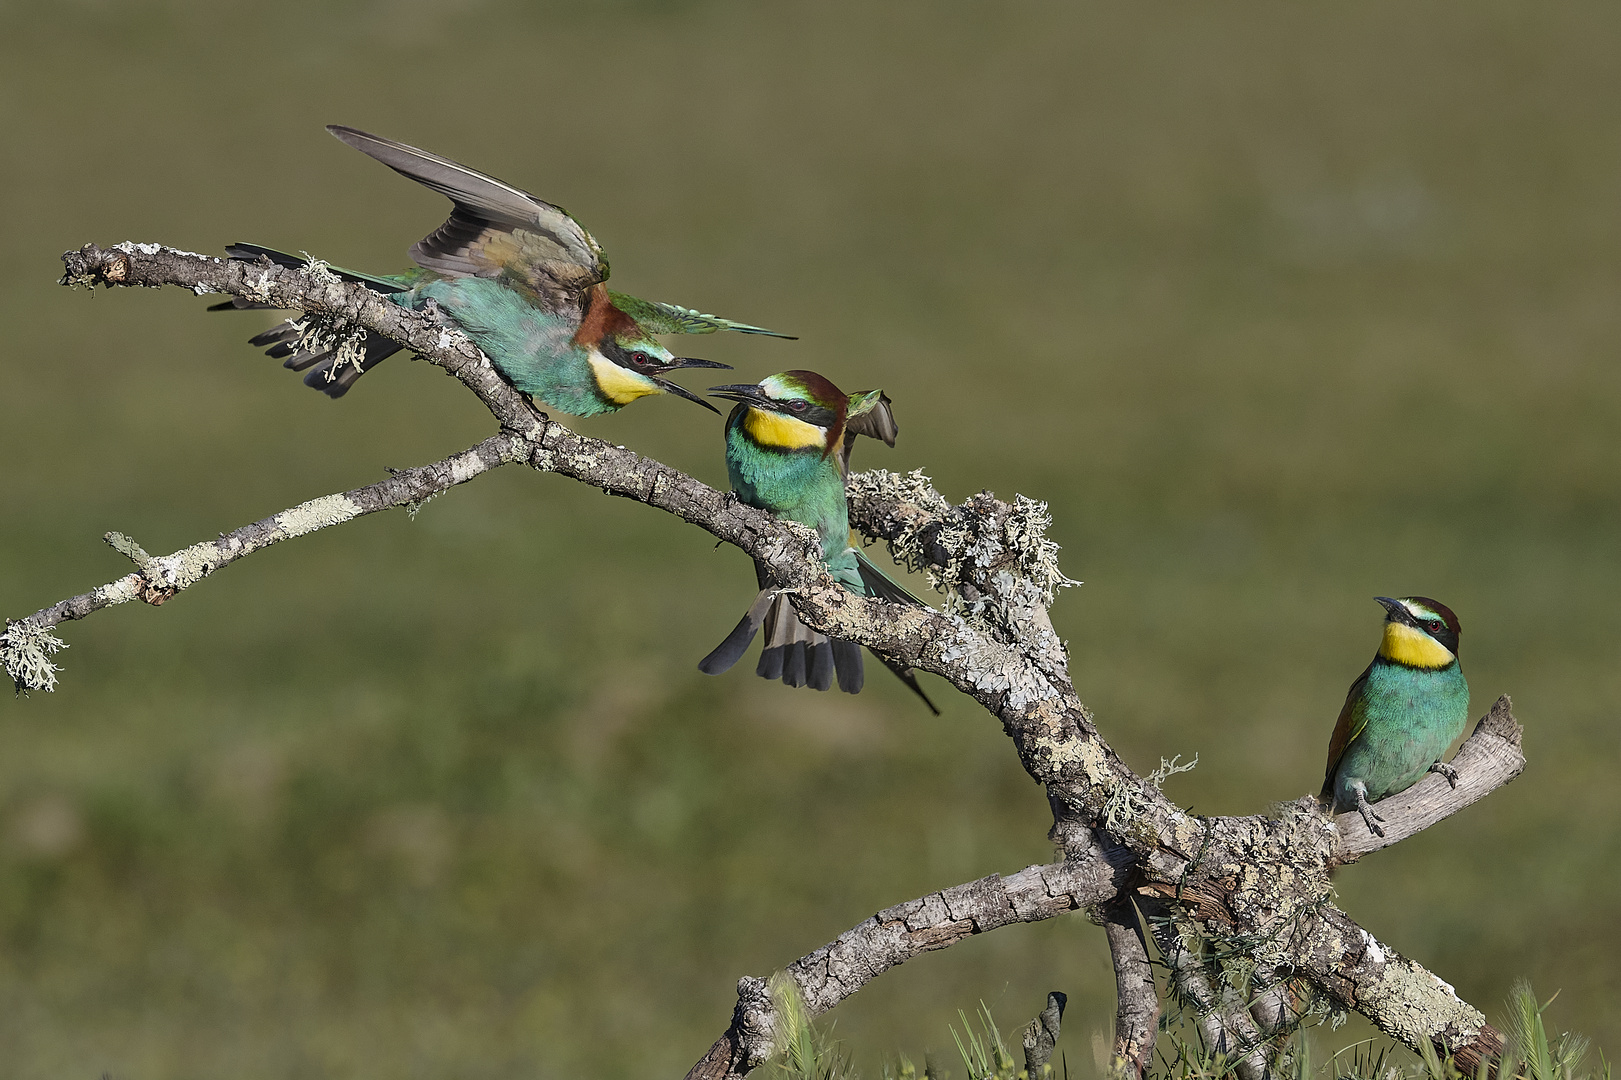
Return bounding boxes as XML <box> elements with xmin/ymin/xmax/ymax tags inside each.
<box><xmin>327</xmin><ymin>123</ymin><xmax>608</xmax><ymax>300</ymax></box>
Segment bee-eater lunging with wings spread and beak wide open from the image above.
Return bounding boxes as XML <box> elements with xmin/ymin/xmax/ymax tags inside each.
<box><xmin>212</xmin><ymin>125</ymin><xmax>788</xmax><ymax>417</ymax></box>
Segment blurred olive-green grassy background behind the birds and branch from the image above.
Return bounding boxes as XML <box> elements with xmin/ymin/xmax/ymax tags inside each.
<box><xmin>0</xmin><ymin>0</ymin><xmax>1621</xmax><ymax>1080</ymax></box>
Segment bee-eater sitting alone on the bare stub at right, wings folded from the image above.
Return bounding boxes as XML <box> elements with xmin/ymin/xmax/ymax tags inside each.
<box><xmin>1319</xmin><ymin>597</ymin><xmax>1469</xmax><ymax>837</ymax></box>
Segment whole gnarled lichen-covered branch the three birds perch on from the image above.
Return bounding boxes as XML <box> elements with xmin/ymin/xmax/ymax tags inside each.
<box><xmin>22</xmin><ymin>243</ymin><xmax>1524</xmax><ymax>1080</ymax></box>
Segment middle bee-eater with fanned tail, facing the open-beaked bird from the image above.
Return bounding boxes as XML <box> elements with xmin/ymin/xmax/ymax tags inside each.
<box><xmin>699</xmin><ymin>371</ymin><xmax>939</xmax><ymax>714</ymax></box>
